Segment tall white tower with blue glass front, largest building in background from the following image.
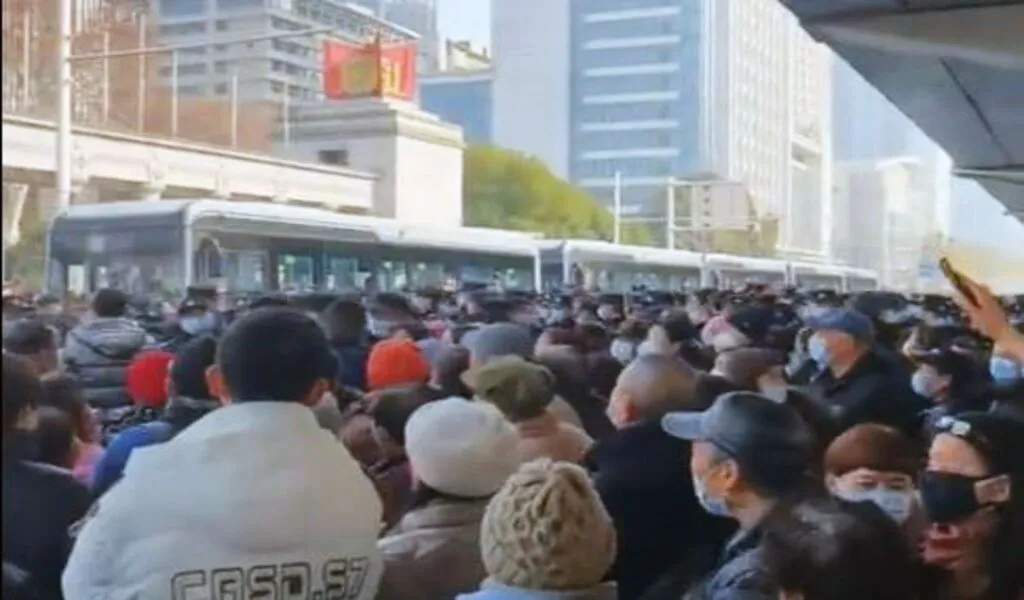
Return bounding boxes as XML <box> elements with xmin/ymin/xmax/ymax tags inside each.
<box><xmin>492</xmin><ymin>0</ymin><xmax>830</xmax><ymax>252</ymax></box>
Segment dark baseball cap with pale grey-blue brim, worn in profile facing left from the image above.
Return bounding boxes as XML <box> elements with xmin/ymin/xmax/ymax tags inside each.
<box><xmin>662</xmin><ymin>391</ymin><xmax>814</xmax><ymax>473</ymax></box>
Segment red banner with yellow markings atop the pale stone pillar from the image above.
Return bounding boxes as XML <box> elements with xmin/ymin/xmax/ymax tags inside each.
<box><xmin>324</xmin><ymin>41</ymin><xmax>416</xmax><ymax>100</ymax></box>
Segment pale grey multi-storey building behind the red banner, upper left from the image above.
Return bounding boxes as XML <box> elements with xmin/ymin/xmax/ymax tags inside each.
<box><xmin>151</xmin><ymin>0</ymin><xmax>417</xmax><ymax>103</ymax></box>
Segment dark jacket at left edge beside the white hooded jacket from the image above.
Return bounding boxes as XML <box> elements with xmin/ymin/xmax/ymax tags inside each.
<box><xmin>3</xmin><ymin>440</ymin><xmax>91</xmax><ymax>600</ymax></box>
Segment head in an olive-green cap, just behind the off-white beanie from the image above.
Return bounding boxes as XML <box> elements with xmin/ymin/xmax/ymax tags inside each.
<box><xmin>463</xmin><ymin>356</ymin><xmax>555</xmax><ymax>423</ymax></box>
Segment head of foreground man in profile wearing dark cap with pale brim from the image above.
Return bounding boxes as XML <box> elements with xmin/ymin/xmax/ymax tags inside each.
<box><xmin>662</xmin><ymin>392</ymin><xmax>814</xmax><ymax>524</ymax></box>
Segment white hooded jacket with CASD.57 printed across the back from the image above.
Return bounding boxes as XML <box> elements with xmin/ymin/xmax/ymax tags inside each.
<box><xmin>62</xmin><ymin>402</ymin><xmax>383</xmax><ymax>600</ymax></box>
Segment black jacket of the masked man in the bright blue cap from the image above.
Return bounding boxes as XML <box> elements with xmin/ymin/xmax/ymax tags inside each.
<box><xmin>809</xmin><ymin>350</ymin><xmax>930</xmax><ymax>438</ymax></box>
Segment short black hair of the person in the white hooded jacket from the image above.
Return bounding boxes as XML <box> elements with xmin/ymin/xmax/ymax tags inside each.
<box><xmin>217</xmin><ymin>307</ymin><xmax>338</xmax><ymax>402</ymax></box>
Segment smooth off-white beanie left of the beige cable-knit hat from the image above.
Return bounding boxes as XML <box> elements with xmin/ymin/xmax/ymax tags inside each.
<box><xmin>406</xmin><ymin>398</ymin><xmax>519</xmax><ymax>499</ymax></box>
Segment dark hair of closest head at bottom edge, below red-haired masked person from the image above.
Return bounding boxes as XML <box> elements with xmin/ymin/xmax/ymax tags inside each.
<box><xmin>762</xmin><ymin>499</ymin><xmax>918</xmax><ymax>600</ymax></box>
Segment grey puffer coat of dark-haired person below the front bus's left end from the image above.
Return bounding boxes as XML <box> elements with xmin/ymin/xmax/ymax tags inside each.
<box><xmin>60</xmin><ymin>317</ymin><xmax>151</xmax><ymax>409</ymax></box>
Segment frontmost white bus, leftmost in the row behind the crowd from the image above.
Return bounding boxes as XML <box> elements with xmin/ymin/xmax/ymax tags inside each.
<box><xmin>46</xmin><ymin>200</ymin><xmax>540</xmax><ymax>296</ymax></box>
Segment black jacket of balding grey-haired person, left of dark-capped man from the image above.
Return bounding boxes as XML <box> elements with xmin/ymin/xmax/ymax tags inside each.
<box><xmin>584</xmin><ymin>420</ymin><xmax>735</xmax><ymax>600</ymax></box>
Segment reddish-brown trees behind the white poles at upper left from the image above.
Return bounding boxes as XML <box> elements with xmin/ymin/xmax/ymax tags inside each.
<box><xmin>2</xmin><ymin>0</ymin><xmax>276</xmax><ymax>152</ymax></box>
